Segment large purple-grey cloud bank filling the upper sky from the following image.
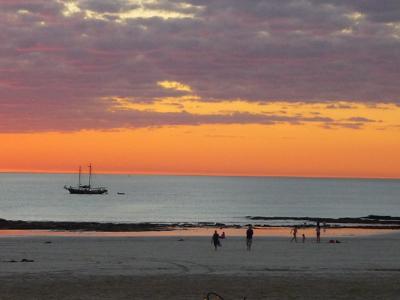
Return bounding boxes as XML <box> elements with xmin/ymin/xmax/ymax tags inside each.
<box><xmin>0</xmin><ymin>0</ymin><xmax>400</xmax><ymax>130</ymax></box>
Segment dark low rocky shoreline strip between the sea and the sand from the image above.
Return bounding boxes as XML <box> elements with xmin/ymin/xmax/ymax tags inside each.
<box><xmin>0</xmin><ymin>215</ymin><xmax>400</xmax><ymax>232</ymax></box>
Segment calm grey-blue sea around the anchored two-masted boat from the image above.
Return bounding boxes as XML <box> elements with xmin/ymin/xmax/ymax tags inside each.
<box><xmin>0</xmin><ymin>173</ymin><xmax>400</xmax><ymax>224</ymax></box>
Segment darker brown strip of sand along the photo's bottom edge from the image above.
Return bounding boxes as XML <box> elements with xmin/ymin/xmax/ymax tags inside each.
<box><xmin>0</xmin><ymin>274</ymin><xmax>400</xmax><ymax>300</ymax></box>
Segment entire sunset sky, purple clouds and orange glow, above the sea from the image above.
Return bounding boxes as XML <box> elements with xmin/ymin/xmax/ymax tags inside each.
<box><xmin>0</xmin><ymin>0</ymin><xmax>400</xmax><ymax>178</ymax></box>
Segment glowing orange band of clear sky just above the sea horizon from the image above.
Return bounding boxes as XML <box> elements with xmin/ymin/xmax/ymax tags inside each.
<box><xmin>0</xmin><ymin>103</ymin><xmax>400</xmax><ymax>178</ymax></box>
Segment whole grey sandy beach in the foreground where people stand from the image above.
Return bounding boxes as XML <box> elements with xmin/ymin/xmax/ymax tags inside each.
<box><xmin>0</xmin><ymin>229</ymin><xmax>400</xmax><ymax>299</ymax></box>
